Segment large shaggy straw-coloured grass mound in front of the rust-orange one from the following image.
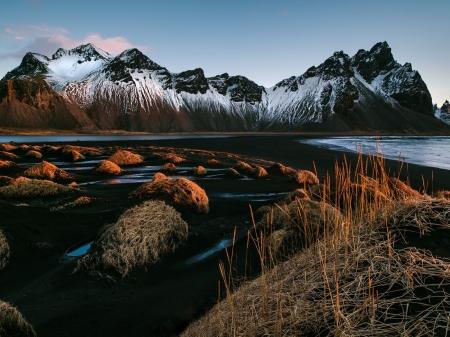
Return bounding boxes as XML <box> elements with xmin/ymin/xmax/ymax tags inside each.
<box><xmin>79</xmin><ymin>200</ymin><xmax>188</xmax><ymax>276</ymax></box>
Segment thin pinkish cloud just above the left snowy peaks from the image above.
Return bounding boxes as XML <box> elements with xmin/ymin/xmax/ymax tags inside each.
<box><xmin>0</xmin><ymin>25</ymin><xmax>151</xmax><ymax>59</ymax></box>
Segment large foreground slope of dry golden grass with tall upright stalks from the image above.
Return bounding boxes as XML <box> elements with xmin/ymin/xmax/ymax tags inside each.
<box><xmin>181</xmin><ymin>147</ymin><xmax>450</xmax><ymax>337</ymax></box>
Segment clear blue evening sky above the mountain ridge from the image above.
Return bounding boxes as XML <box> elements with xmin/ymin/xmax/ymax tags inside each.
<box><xmin>0</xmin><ymin>0</ymin><xmax>450</xmax><ymax>106</ymax></box>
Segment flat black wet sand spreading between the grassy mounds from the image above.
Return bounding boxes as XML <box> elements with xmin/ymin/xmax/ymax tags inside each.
<box><xmin>0</xmin><ymin>135</ymin><xmax>450</xmax><ymax>336</ymax></box>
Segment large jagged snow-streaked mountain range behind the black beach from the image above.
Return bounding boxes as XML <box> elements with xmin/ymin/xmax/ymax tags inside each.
<box><xmin>0</xmin><ymin>42</ymin><xmax>448</xmax><ymax>132</ymax></box>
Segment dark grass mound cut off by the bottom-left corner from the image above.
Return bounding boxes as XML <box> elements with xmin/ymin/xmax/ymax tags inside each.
<box><xmin>0</xmin><ymin>301</ymin><xmax>36</xmax><ymax>337</ymax></box>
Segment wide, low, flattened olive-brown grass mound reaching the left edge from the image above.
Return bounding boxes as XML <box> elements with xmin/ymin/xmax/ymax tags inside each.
<box><xmin>0</xmin><ymin>178</ymin><xmax>72</xmax><ymax>198</ymax></box>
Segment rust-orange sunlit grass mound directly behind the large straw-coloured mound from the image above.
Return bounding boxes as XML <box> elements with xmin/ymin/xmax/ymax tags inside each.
<box><xmin>131</xmin><ymin>178</ymin><xmax>209</xmax><ymax>214</ymax></box>
